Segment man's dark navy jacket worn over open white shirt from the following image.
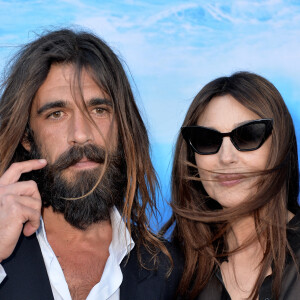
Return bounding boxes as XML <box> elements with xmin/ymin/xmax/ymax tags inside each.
<box><xmin>0</xmin><ymin>234</ymin><xmax>182</xmax><ymax>300</ymax></box>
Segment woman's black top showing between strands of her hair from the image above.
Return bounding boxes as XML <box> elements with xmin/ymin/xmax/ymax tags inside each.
<box><xmin>197</xmin><ymin>212</ymin><xmax>300</xmax><ymax>300</ymax></box>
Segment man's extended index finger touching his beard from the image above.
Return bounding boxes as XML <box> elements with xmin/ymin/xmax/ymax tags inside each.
<box><xmin>0</xmin><ymin>159</ymin><xmax>47</xmax><ymax>185</ymax></box>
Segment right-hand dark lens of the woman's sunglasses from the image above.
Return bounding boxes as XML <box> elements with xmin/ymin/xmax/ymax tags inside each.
<box><xmin>233</xmin><ymin>123</ymin><xmax>266</xmax><ymax>151</ymax></box>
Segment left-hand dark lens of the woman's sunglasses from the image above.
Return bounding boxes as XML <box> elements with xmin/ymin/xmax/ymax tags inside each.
<box><xmin>188</xmin><ymin>127</ymin><xmax>222</xmax><ymax>154</ymax></box>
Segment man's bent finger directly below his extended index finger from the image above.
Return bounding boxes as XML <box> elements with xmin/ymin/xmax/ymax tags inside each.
<box><xmin>0</xmin><ymin>180</ymin><xmax>41</xmax><ymax>199</ymax></box>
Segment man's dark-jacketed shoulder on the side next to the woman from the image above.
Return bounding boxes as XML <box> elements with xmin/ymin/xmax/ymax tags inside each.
<box><xmin>120</xmin><ymin>241</ymin><xmax>183</xmax><ymax>300</ymax></box>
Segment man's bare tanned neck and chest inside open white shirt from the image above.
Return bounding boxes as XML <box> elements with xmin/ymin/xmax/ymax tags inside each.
<box><xmin>43</xmin><ymin>208</ymin><xmax>112</xmax><ymax>300</ymax></box>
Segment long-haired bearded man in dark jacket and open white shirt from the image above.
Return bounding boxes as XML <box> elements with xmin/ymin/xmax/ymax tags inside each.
<box><xmin>0</xmin><ymin>29</ymin><xmax>180</xmax><ymax>300</ymax></box>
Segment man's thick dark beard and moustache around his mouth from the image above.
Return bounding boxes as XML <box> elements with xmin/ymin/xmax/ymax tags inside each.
<box><xmin>22</xmin><ymin>141</ymin><xmax>127</xmax><ymax>230</ymax></box>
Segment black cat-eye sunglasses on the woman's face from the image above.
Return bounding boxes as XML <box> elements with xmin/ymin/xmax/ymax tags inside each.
<box><xmin>181</xmin><ymin>119</ymin><xmax>273</xmax><ymax>155</ymax></box>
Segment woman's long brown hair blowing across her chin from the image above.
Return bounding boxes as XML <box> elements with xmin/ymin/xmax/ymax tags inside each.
<box><xmin>163</xmin><ymin>72</ymin><xmax>299</xmax><ymax>299</ymax></box>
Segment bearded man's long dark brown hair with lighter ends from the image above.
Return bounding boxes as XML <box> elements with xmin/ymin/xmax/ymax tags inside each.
<box><xmin>0</xmin><ymin>29</ymin><xmax>168</xmax><ymax>264</ymax></box>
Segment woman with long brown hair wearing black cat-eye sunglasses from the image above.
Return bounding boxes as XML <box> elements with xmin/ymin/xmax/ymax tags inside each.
<box><xmin>164</xmin><ymin>72</ymin><xmax>300</xmax><ymax>300</ymax></box>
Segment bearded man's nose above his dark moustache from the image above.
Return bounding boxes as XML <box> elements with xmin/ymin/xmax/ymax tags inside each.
<box><xmin>68</xmin><ymin>112</ymin><xmax>94</xmax><ymax>145</ymax></box>
